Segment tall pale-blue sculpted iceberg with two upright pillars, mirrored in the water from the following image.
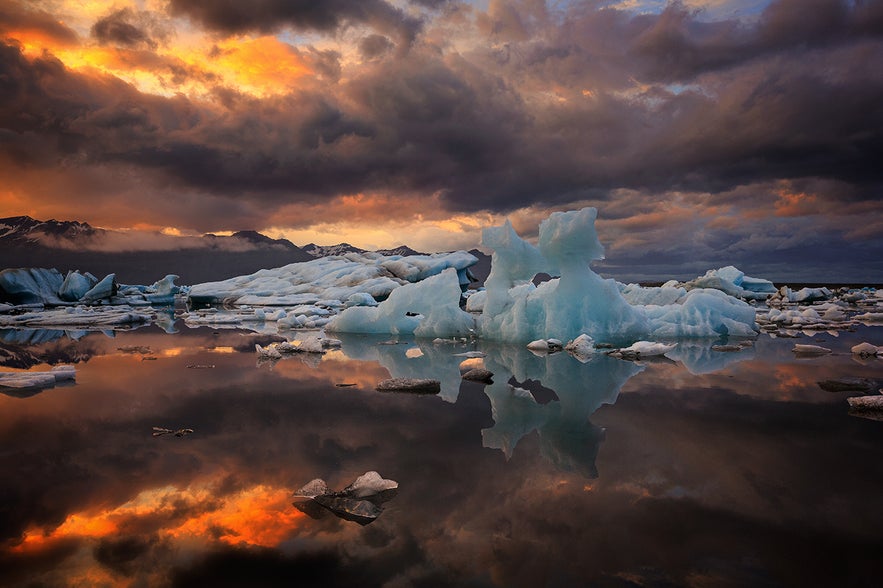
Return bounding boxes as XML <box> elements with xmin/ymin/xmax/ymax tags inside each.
<box><xmin>327</xmin><ymin>208</ymin><xmax>767</xmax><ymax>342</ymax></box>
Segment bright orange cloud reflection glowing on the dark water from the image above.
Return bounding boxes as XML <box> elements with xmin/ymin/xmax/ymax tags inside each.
<box><xmin>13</xmin><ymin>485</ymin><xmax>306</xmax><ymax>552</ymax></box>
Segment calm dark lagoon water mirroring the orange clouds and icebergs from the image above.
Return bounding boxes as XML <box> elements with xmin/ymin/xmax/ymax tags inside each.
<box><xmin>0</xmin><ymin>328</ymin><xmax>883</xmax><ymax>587</ymax></box>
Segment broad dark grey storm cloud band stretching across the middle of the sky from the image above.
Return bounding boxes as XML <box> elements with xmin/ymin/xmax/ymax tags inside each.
<box><xmin>6</xmin><ymin>2</ymin><xmax>883</xmax><ymax>210</ymax></box>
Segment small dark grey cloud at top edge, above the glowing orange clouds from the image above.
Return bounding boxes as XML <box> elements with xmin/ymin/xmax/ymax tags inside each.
<box><xmin>169</xmin><ymin>0</ymin><xmax>421</xmax><ymax>44</ymax></box>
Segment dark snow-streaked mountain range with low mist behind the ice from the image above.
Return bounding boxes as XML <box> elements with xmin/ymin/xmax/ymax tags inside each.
<box><xmin>0</xmin><ymin>216</ymin><xmax>489</xmax><ymax>284</ymax></box>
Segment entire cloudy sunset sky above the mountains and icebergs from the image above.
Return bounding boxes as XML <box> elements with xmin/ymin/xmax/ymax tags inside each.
<box><xmin>0</xmin><ymin>0</ymin><xmax>883</xmax><ymax>282</ymax></box>
